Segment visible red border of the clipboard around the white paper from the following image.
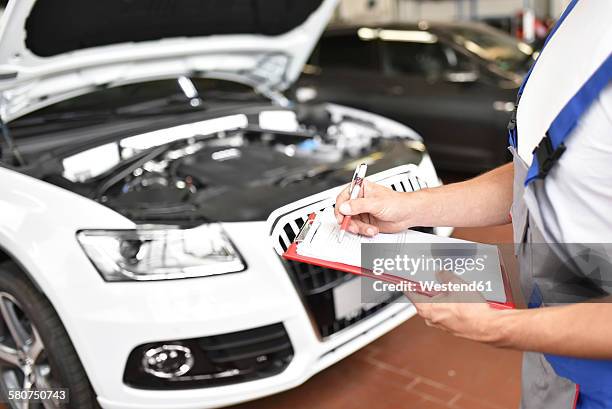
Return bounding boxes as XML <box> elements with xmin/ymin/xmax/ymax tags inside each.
<box><xmin>283</xmin><ymin>213</ymin><xmax>516</xmax><ymax>310</ymax></box>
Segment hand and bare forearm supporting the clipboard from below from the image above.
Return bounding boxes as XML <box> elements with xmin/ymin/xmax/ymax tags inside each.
<box><xmin>406</xmin><ymin>272</ymin><xmax>612</xmax><ymax>360</ymax></box>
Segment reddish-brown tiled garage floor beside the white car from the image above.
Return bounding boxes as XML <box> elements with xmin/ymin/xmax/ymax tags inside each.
<box><xmin>232</xmin><ymin>226</ymin><xmax>521</xmax><ymax>409</ymax></box>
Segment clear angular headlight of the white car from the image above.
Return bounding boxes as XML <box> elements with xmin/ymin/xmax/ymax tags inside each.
<box><xmin>77</xmin><ymin>224</ymin><xmax>245</xmax><ymax>281</ymax></box>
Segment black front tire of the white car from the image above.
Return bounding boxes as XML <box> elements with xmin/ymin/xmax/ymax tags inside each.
<box><xmin>0</xmin><ymin>262</ymin><xmax>100</xmax><ymax>409</ymax></box>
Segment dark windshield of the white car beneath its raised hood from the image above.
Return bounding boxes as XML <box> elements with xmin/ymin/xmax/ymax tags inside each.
<box><xmin>9</xmin><ymin>77</ymin><xmax>268</xmax><ymax>140</ymax></box>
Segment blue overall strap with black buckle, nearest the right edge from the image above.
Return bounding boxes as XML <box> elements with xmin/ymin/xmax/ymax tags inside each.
<box><xmin>525</xmin><ymin>54</ymin><xmax>612</xmax><ymax>186</ymax></box>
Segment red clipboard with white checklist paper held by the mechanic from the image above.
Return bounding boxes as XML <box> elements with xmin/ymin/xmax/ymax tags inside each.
<box><xmin>283</xmin><ymin>207</ymin><xmax>515</xmax><ymax>309</ymax></box>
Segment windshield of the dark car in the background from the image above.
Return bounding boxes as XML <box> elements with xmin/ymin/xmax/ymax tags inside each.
<box><xmin>452</xmin><ymin>26</ymin><xmax>534</xmax><ymax>72</ymax></box>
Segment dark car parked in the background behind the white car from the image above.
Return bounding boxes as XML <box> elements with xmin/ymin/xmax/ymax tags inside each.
<box><xmin>294</xmin><ymin>22</ymin><xmax>537</xmax><ymax>172</ymax></box>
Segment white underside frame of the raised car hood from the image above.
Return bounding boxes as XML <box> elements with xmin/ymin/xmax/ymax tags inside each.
<box><xmin>0</xmin><ymin>0</ymin><xmax>338</xmax><ymax>121</ymax></box>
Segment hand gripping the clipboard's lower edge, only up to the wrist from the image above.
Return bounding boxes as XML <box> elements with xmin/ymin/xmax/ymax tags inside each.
<box><xmin>406</xmin><ymin>271</ymin><xmax>504</xmax><ymax>344</ymax></box>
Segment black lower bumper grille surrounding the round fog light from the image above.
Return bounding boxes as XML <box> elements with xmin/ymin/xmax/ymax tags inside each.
<box><xmin>123</xmin><ymin>323</ymin><xmax>293</xmax><ymax>389</ymax></box>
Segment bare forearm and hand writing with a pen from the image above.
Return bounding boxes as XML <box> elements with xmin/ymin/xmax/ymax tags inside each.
<box><xmin>335</xmin><ymin>163</ymin><xmax>514</xmax><ymax>236</ymax></box>
